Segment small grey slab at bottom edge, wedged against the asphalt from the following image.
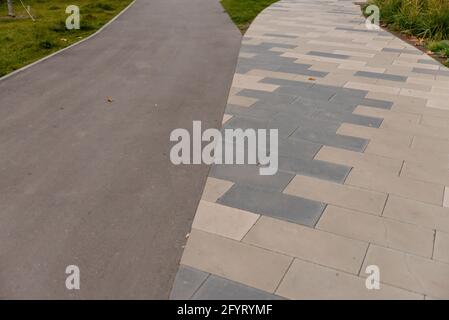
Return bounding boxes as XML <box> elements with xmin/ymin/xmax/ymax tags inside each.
<box><xmin>170</xmin><ymin>265</ymin><xmax>209</xmax><ymax>300</ymax></box>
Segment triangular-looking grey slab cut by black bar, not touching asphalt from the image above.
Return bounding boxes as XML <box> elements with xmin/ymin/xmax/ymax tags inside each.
<box><xmin>192</xmin><ymin>275</ymin><xmax>284</xmax><ymax>300</ymax></box>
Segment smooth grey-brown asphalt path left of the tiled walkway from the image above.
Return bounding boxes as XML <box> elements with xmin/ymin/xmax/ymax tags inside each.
<box><xmin>0</xmin><ymin>0</ymin><xmax>241</xmax><ymax>299</ymax></box>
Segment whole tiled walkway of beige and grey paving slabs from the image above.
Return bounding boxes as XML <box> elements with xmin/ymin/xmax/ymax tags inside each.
<box><xmin>172</xmin><ymin>0</ymin><xmax>449</xmax><ymax>299</ymax></box>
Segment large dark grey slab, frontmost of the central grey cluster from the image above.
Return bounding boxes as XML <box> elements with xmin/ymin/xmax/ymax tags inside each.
<box><xmin>218</xmin><ymin>185</ymin><xmax>324</xmax><ymax>226</ymax></box>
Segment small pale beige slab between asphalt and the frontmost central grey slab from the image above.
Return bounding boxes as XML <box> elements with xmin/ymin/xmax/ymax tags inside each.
<box><xmin>192</xmin><ymin>200</ymin><xmax>259</xmax><ymax>240</ymax></box>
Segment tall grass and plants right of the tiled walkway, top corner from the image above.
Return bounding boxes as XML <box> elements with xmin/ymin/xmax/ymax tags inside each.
<box><xmin>367</xmin><ymin>0</ymin><xmax>449</xmax><ymax>65</ymax></box>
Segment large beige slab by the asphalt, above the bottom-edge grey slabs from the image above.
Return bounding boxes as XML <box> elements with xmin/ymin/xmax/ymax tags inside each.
<box><xmin>181</xmin><ymin>230</ymin><xmax>292</xmax><ymax>292</ymax></box>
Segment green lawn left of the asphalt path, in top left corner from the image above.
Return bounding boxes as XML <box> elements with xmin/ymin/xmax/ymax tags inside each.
<box><xmin>0</xmin><ymin>0</ymin><xmax>132</xmax><ymax>76</ymax></box>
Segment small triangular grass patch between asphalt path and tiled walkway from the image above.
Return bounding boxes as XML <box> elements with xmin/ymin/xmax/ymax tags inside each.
<box><xmin>221</xmin><ymin>0</ymin><xmax>278</xmax><ymax>33</ymax></box>
